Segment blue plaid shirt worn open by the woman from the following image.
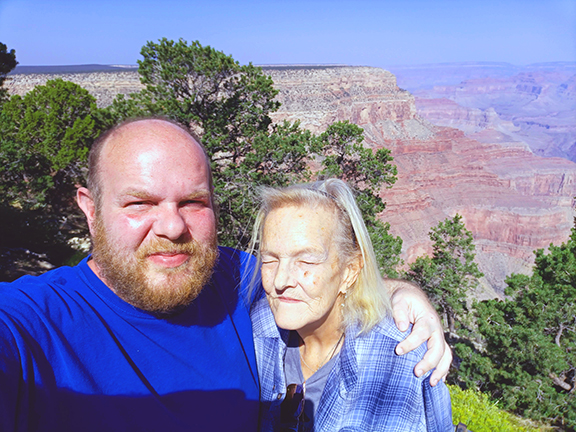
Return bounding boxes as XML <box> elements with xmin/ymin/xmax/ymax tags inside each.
<box><xmin>251</xmin><ymin>298</ymin><xmax>454</xmax><ymax>432</ymax></box>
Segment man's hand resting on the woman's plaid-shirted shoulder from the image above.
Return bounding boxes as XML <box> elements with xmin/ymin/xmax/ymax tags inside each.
<box><xmin>386</xmin><ymin>279</ymin><xmax>452</xmax><ymax>386</ymax></box>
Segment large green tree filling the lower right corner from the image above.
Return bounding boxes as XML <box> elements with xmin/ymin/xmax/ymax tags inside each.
<box><xmin>456</xmin><ymin>221</ymin><xmax>576</xmax><ymax>431</ymax></box>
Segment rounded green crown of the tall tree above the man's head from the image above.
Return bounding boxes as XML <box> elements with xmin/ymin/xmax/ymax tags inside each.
<box><xmin>111</xmin><ymin>38</ymin><xmax>279</xmax><ymax>154</ymax></box>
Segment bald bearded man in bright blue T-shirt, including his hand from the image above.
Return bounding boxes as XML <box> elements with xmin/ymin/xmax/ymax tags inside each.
<box><xmin>0</xmin><ymin>119</ymin><xmax>449</xmax><ymax>431</ymax></box>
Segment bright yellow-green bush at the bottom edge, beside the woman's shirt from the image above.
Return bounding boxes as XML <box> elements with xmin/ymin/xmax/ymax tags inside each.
<box><xmin>448</xmin><ymin>386</ymin><xmax>544</xmax><ymax>432</ymax></box>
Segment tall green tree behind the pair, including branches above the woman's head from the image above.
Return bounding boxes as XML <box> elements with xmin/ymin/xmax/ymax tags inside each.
<box><xmin>108</xmin><ymin>39</ymin><xmax>401</xmax><ymax>275</ymax></box>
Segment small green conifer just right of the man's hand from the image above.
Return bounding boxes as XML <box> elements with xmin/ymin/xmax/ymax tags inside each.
<box><xmin>407</xmin><ymin>214</ymin><xmax>483</xmax><ymax>333</ymax></box>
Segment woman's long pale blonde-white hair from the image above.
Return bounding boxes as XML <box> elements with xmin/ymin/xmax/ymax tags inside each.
<box><xmin>249</xmin><ymin>179</ymin><xmax>391</xmax><ymax>333</ymax></box>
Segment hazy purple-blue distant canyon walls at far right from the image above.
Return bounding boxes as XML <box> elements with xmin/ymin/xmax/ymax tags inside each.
<box><xmin>415</xmin><ymin>64</ymin><xmax>576</xmax><ymax>161</ymax></box>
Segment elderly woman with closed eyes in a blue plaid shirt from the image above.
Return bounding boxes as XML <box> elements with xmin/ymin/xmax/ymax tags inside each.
<box><xmin>251</xmin><ymin>179</ymin><xmax>453</xmax><ymax>432</ymax></box>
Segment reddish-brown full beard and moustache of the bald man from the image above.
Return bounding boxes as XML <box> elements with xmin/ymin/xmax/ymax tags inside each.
<box><xmin>92</xmin><ymin>216</ymin><xmax>218</xmax><ymax>314</ymax></box>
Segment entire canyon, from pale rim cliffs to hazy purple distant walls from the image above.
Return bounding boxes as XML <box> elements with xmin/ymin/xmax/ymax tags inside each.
<box><xmin>6</xmin><ymin>66</ymin><xmax>576</xmax><ymax>298</ymax></box>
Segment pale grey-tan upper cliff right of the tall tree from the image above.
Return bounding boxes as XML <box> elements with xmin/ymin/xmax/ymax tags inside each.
<box><xmin>266</xmin><ymin>67</ymin><xmax>433</xmax><ymax>141</ymax></box>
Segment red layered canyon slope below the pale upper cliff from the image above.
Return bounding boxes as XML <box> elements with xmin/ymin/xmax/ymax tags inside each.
<box><xmin>382</xmin><ymin>129</ymin><xmax>576</xmax><ymax>293</ymax></box>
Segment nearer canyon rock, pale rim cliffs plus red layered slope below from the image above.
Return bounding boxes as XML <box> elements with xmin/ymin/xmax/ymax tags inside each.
<box><xmin>8</xmin><ymin>67</ymin><xmax>576</xmax><ymax>295</ymax></box>
